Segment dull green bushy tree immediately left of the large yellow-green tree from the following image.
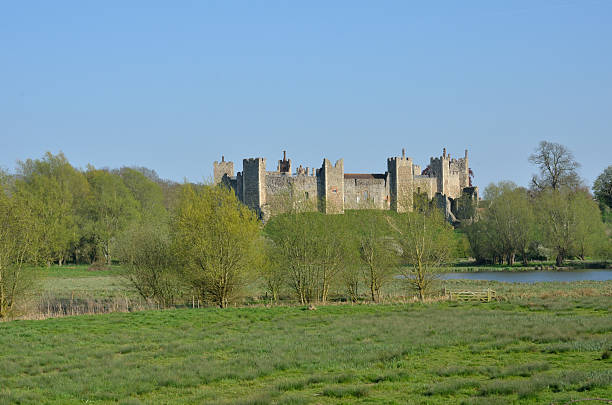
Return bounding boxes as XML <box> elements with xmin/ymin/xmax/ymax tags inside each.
<box><xmin>117</xmin><ymin>221</ymin><xmax>184</xmax><ymax>308</ymax></box>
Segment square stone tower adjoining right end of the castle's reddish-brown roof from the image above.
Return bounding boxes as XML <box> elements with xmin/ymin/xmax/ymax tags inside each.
<box><xmin>387</xmin><ymin>150</ymin><xmax>414</xmax><ymax>212</ymax></box>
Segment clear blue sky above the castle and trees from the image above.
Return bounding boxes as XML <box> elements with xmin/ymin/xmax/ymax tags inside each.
<box><xmin>0</xmin><ymin>0</ymin><xmax>612</xmax><ymax>188</ymax></box>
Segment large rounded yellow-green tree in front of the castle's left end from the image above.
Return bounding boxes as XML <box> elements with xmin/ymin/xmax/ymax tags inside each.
<box><xmin>172</xmin><ymin>185</ymin><xmax>263</xmax><ymax>308</ymax></box>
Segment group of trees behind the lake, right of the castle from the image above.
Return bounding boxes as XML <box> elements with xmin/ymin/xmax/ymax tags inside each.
<box><xmin>462</xmin><ymin>142</ymin><xmax>612</xmax><ymax>266</ymax></box>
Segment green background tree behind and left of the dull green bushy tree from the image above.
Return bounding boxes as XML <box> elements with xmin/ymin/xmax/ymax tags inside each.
<box><xmin>85</xmin><ymin>166</ymin><xmax>140</xmax><ymax>265</ymax></box>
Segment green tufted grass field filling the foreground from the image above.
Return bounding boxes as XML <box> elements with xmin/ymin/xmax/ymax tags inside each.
<box><xmin>0</xmin><ymin>296</ymin><xmax>612</xmax><ymax>404</ymax></box>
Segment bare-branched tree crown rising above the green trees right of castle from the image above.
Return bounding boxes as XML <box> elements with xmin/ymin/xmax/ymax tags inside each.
<box><xmin>529</xmin><ymin>141</ymin><xmax>582</xmax><ymax>191</ymax></box>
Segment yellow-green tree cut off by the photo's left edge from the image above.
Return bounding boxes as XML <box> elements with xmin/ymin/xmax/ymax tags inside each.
<box><xmin>0</xmin><ymin>179</ymin><xmax>41</xmax><ymax>319</ymax></box>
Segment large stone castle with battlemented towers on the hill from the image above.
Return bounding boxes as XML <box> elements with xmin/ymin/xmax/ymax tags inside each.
<box><xmin>213</xmin><ymin>149</ymin><xmax>478</xmax><ymax>222</ymax></box>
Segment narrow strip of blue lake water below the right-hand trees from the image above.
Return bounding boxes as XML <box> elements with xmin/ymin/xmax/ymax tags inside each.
<box><xmin>441</xmin><ymin>270</ymin><xmax>612</xmax><ymax>283</ymax></box>
